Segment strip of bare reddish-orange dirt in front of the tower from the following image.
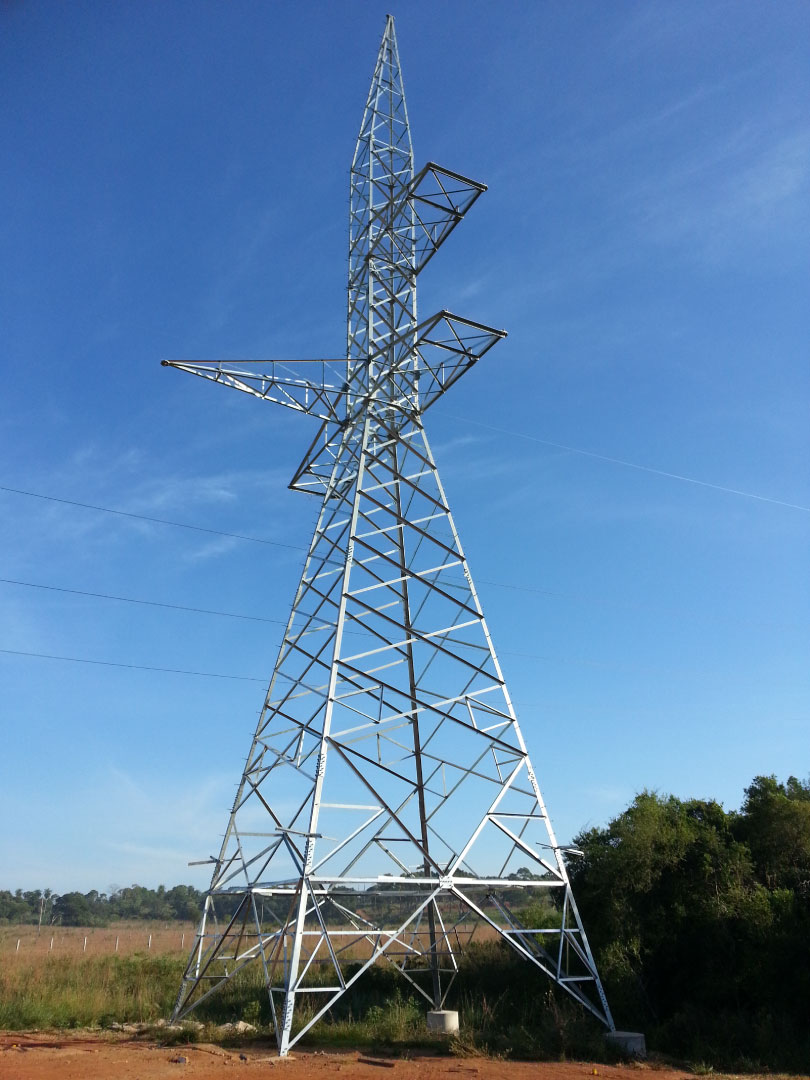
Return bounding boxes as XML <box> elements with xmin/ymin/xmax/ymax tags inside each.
<box><xmin>0</xmin><ymin>1031</ymin><xmax>693</xmax><ymax>1080</ymax></box>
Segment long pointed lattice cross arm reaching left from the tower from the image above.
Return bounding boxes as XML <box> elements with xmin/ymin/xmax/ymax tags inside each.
<box><xmin>161</xmin><ymin>359</ymin><xmax>348</xmax><ymax>420</ymax></box>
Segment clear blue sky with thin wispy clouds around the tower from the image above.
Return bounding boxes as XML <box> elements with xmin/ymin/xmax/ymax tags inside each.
<box><xmin>0</xmin><ymin>0</ymin><xmax>810</xmax><ymax>891</ymax></box>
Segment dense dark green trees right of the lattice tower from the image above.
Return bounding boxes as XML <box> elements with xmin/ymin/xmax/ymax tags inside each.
<box><xmin>570</xmin><ymin>777</ymin><xmax>810</xmax><ymax>1070</ymax></box>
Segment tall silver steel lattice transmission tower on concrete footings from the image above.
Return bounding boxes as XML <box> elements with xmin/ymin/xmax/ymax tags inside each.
<box><xmin>164</xmin><ymin>16</ymin><xmax>613</xmax><ymax>1055</ymax></box>
